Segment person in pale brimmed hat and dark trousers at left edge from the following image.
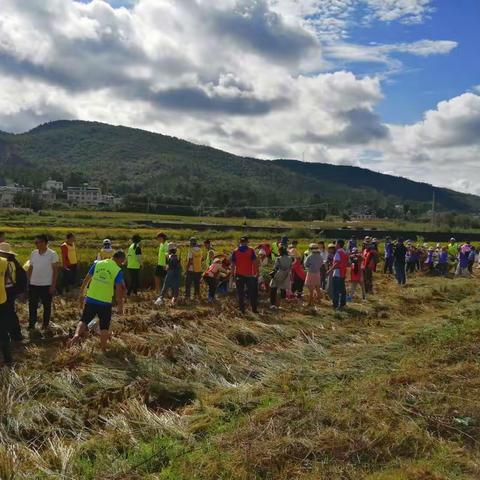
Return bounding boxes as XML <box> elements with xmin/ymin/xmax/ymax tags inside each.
<box><xmin>0</xmin><ymin>242</ymin><xmax>27</xmax><ymax>342</ymax></box>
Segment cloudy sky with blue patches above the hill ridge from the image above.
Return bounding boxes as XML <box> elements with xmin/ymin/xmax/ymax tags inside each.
<box><xmin>0</xmin><ymin>0</ymin><xmax>480</xmax><ymax>194</ymax></box>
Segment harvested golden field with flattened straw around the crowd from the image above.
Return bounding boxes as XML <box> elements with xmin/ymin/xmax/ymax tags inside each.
<box><xmin>0</xmin><ymin>213</ymin><xmax>480</xmax><ymax>480</ymax></box>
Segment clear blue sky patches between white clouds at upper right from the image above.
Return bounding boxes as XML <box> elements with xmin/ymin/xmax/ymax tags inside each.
<box><xmin>364</xmin><ymin>0</ymin><xmax>480</xmax><ymax>123</ymax></box>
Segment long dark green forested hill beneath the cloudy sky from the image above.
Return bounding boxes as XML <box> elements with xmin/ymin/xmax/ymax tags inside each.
<box><xmin>0</xmin><ymin>121</ymin><xmax>480</xmax><ymax>212</ymax></box>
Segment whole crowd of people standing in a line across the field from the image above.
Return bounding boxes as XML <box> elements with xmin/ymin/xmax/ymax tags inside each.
<box><xmin>0</xmin><ymin>232</ymin><xmax>478</xmax><ymax>364</ymax></box>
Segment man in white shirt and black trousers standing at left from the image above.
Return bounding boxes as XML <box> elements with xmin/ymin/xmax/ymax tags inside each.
<box><xmin>28</xmin><ymin>235</ymin><xmax>59</xmax><ymax>330</ymax></box>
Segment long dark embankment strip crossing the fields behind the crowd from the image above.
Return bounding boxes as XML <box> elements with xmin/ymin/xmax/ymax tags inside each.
<box><xmin>135</xmin><ymin>220</ymin><xmax>480</xmax><ymax>242</ymax></box>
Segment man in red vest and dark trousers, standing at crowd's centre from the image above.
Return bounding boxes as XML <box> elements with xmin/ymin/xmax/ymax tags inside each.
<box><xmin>231</xmin><ymin>237</ymin><xmax>258</xmax><ymax>313</ymax></box>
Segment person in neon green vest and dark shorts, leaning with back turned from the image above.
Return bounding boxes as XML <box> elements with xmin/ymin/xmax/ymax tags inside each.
<box><xmin>70</xmin><ymin>250</ymin><xmax>125</xmax><ymax>351</ymax></box>
